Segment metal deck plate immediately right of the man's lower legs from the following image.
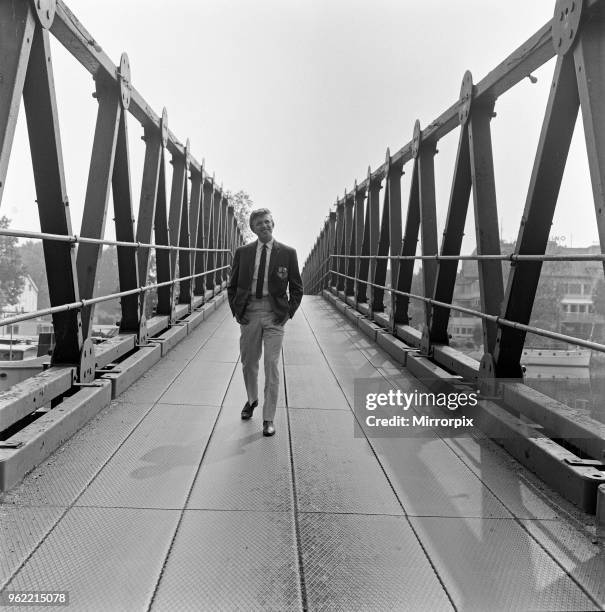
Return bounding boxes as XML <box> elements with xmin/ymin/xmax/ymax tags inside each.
<box><xmin>286</xmin><ymin>366</ymin><xmax>350</xmax><ymax>410</ymax></box>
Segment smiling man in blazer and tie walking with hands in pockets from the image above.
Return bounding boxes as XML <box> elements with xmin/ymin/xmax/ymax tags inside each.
<box><xmin>227</xmin><ymin>208</ymin><xmax>303</xmax><ymax>436</ymax></box>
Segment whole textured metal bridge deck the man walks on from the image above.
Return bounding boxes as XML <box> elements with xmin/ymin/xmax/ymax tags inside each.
<box><xmin>0</xmin><ymin>296</ymin><xmax>605</xmax><ymax>611</ymax></box>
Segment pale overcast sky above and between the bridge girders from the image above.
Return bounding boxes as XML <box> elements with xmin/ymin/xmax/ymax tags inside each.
<box><xmin>1</xmin><ymin>0</ymin><xmax>597</xmax><ymax>263</ymax></box>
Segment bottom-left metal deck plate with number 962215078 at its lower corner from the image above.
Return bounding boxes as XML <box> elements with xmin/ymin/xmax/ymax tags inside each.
<box><xmin>7</xmin><ymin>508</ymin><xmax>179</xmax><ymax>612</ymax></box>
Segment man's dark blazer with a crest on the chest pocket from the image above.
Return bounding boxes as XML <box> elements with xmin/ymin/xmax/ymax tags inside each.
<box><xmin>227</xmin><ymin>239</ymin><xmax>303</xmax><ymax>319</ymax></box>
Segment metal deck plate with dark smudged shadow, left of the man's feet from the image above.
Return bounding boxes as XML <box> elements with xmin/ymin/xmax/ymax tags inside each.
<box><xmin>77</xmin><ymin>404</ymin><xmax>218</xmax><ymax>508</ymax></box>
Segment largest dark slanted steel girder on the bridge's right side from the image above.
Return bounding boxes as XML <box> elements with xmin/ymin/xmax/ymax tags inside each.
<box><xmin>493</xmin><ymin>54</ymin><xmax>580</xmax><ymax>378</ymax></box>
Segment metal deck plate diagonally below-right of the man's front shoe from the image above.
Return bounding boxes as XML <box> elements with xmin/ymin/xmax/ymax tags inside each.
<box><xmin>290</xmin><ymin>409</ymin><xmax>403</xmax><ymax>514</ymax></box>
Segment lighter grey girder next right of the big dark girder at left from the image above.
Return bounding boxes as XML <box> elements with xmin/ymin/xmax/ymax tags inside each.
<box><xmin>77</xmin><ymin>76</ymin><xmax>121</xmax><ymax>338</ymax></box>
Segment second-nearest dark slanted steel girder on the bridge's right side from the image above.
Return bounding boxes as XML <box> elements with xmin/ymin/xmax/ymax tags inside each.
<box><xmin>429</xmin><ymin>123</ymin><xmax>472</xmax><ymax>344</ymax></box>
